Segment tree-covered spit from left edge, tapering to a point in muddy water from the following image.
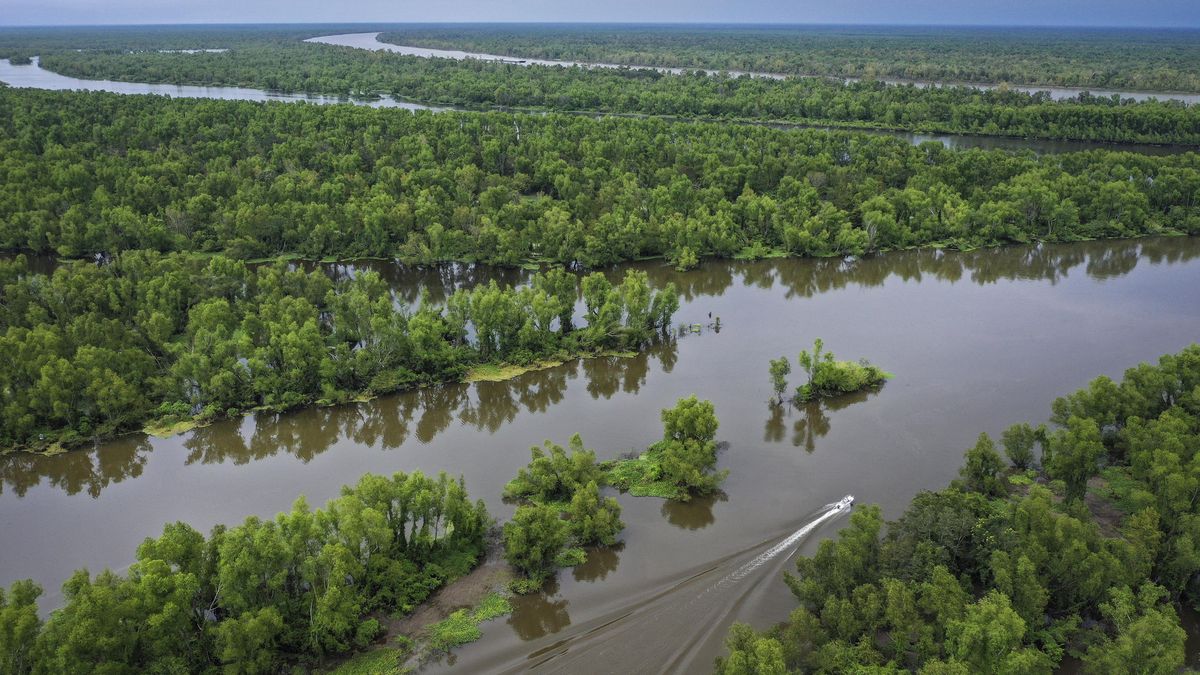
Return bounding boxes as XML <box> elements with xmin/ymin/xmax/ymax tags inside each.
<box><xmin>0</xmin><ymin>252</ymin><xmax>678</xmax><ymax>448</ymax></box>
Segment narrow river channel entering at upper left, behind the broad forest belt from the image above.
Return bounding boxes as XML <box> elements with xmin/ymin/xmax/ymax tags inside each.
<box><xmin>0</xmin><ymin>54</ymin><xmax>1196</xmax><ymax>155</ymax></box>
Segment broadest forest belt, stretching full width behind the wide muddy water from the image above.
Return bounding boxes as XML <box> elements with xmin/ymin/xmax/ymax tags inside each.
<box><xmin>7</xmin><ymin>90</ymin><xmax>1200</xmax><ymax>267</ymax></box>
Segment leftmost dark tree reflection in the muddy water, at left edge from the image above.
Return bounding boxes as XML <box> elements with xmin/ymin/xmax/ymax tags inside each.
<box><xmin>0</xmin><ymin>436</ymin><xmax>150</xmax><ymax>497</ymax></box>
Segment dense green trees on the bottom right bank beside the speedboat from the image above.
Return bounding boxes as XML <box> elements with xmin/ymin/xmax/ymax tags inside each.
<box><xmin>718</xmin><ymin>345</ymin><xmax>1200</xmax><ymax>675</ymax></box>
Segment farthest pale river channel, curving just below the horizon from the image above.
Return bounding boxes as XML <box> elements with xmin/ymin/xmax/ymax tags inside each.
<box><xmin>305</xmin><ymin>32</ymin><xmax>1200</xmax><ymax>104</ymax></box>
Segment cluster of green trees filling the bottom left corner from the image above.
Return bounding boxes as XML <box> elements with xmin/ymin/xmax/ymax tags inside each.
<box><xmin>0</xmin><ymin>472</ymin><xmax>492</xmax><ymax>675</ymax></box>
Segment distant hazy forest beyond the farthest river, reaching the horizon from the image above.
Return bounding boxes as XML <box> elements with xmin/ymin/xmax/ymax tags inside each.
<box><xmin>380</xmin><ymin>24</ymin><xmax>1200</xmax><ymax>91</ymax></box>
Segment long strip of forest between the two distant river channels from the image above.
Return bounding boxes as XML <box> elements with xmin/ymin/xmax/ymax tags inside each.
<box><xmin>16</xmin><ymin>39</ymin><xmax>1200</xmax><ymax>144</ymax></box>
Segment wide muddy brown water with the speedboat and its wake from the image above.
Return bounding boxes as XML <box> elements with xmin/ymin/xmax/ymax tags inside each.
<box><xmin>0</xmin><ymin>238</ymin><xmax>1200</xmax><ymax>673</ymax></box>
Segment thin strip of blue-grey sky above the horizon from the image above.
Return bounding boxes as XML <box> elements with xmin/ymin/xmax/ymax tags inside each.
<box><xmin>7</xmin><ymin>0</ymin><xmax>1200</xmax><ymax>28</ymax></box>
